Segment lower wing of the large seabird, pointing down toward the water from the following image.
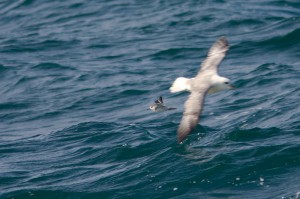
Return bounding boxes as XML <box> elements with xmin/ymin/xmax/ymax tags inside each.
<box><xmin>177</xmin><ymin>87</ymin><xmax>208</xmax><ymax>143</ymax></box>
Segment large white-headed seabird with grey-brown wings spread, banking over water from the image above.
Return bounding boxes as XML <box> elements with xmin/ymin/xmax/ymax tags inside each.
<box><xmin>170</xmin><ymin>36</ymin><xmax>235</xmax><ymax>143</ymax></box>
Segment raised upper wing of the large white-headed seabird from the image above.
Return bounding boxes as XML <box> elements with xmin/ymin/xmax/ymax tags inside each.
<box><xmin>199</xmin><ymin>37</ymin><xmax>229</xmax><ymax>73</ymax></box>
